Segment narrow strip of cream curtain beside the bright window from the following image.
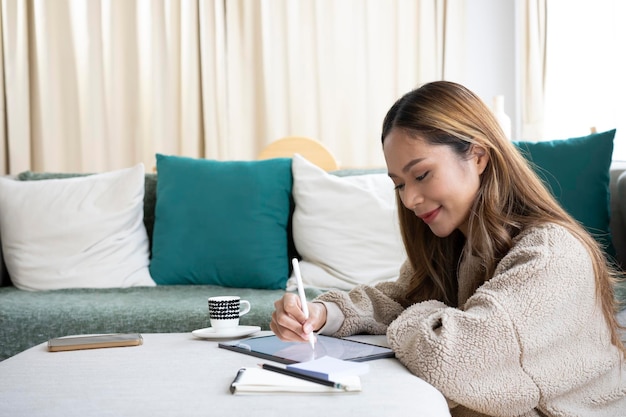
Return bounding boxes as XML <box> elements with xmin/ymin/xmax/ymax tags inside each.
<box><xmin>519</xmin><ymin>0</ymin><xmax>548</xmax><ymax>140</ymax></box>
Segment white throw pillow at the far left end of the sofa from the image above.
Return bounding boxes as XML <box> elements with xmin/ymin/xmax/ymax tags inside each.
<box><xmin>0</xmin><ymin>164</ymin><xmax>155</xmax><ymax>291</ymax></box>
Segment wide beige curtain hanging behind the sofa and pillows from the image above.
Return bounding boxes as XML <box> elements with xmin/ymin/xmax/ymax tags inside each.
<box><xmin>0</xmin><ymin>0</ymin><xmax>446</xmax><ymax>174</ymax></box>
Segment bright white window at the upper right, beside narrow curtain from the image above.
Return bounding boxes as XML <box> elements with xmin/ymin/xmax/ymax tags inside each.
<box><xmin>544</xmin><ymin>0</ymin><xmax>626</xmax><ymax>161</ymax></box>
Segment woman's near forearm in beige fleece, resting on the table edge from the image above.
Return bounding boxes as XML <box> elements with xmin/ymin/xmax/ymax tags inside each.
<box><xmin>387</xmin><ymin>290</ymin><xmax>539</xmax><ymax>415</ymax></box>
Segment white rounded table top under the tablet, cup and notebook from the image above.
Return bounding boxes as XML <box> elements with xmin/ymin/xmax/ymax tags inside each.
<box><xmin>0</xmin><ymin>332</ymin><xmax>450</xmax><ymax>417</ymax></box>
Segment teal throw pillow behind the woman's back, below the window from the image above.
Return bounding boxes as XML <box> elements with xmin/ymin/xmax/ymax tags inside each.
<box><xmin>515</xmin><ymin>129</ymin><xmax>615</xmax><ymax>256</ymax></box>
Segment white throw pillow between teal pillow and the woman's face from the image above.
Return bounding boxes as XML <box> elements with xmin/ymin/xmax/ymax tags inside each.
<box><xmin>287</xmin><ymin>154</ymin><xmax>406</xmax><ymax>290</ymax></box>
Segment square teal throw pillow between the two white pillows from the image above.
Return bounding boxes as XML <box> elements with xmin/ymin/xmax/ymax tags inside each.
<box><xmin>150</xmin><ymin>154</ymin><xmax>293</xmax><ymax>289</ymax></box>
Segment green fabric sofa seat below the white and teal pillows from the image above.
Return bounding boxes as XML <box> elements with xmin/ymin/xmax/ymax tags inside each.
<box><xmin>0</xmin><ymin>173</ymin><xmax>332</xmax><ymax>360</ymax></box>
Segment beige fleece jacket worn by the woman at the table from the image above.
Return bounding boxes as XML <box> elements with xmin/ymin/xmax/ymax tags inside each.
<box><xmin>317</xmin><ymin>225</ymin><xmax>626</xmax><ymax>417</ymax></box>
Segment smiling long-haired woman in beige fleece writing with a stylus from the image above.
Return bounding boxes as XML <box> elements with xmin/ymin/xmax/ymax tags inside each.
<box><xmin>270</xmin><ymin>81</ymin><xmax>626</xmax><ymax>417</ymax></box>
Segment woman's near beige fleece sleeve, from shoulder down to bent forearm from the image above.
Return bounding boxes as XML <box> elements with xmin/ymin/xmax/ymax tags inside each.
<box><xmin>387</xmin><ymin>227</ymin><xmax>606</xmax><ymax>416</ymax></box>
